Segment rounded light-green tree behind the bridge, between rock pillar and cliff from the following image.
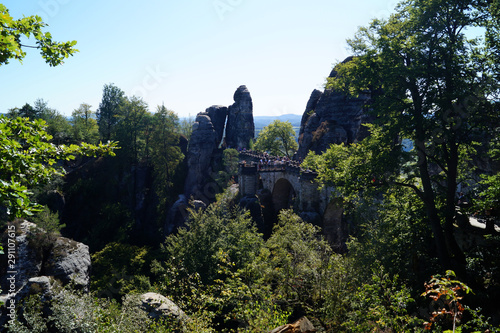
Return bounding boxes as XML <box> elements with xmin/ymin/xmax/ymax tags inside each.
<box><xmin>255</xmin><ymin>119</ymin><xmax>298</xmax><ymax>157</ymax></box>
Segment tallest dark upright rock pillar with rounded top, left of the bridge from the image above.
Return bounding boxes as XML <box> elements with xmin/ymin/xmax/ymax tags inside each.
<box><xmin>226</xmin><ymin>86</ymin><xmax>255</xmax><ymax>149</ymax></box>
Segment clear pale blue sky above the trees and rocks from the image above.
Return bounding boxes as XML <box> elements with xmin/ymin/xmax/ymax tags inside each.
<box><xmin>0</xmin><ymin>0</ymin><xmax>397</xmax><ymax>117</ymax></box>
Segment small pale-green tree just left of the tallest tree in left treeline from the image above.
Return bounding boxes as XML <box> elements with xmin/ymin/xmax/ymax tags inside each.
<box><xmin>71</xmin><ymin>103</ymin><xmax>99</xmax><ymax>143</ymax></box>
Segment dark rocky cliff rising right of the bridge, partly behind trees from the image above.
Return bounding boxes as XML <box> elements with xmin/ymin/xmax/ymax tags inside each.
<box><xmin>297</xmin><ymin>59</ymin><xmax>370</xmax><ymax>159</ymax></box>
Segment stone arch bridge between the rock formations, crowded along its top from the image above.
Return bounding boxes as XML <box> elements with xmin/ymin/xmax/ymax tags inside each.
<box><xmin>239</xmin><ymin>152</ymin><xmax>347</xmax><ymax>250</ymax></box>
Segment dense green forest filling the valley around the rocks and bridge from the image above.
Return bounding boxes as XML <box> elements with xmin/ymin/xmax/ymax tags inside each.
<box><xmin>0</xmin><ymin>0</ymin><xmax>500</xmax><ymax>333</ymax></box>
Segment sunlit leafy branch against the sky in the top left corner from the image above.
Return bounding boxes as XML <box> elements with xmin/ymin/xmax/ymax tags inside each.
<box><xmin>0</xmin><ymin>4</ymin><xmax>78</xmax><ymax>66</ymax></box>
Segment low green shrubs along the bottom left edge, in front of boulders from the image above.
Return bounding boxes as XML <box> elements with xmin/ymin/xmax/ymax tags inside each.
<box><xmin>6</xmin><ymin>289</ymin><xmax>193</xmax><ymax>333</ymax></box>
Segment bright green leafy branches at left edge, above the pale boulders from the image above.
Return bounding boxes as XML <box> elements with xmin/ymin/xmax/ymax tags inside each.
<box><xmin>0</xmin><ymin>116</ymin><xmax>116</xmax><ymax>218</ymax></box>
